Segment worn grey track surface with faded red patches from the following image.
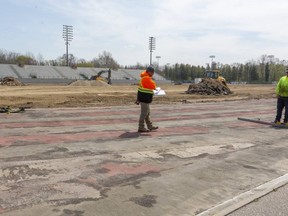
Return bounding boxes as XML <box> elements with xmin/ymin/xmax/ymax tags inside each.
<box><xmin>0</xmin><ymin>99</ymin><xmax>288</xmax><ymax>216</ymax></box>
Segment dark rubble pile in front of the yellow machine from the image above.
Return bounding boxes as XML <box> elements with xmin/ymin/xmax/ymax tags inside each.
<box><xmin>186</xmin><ymin>78</ymin><xmax>232</xmax><ymax>95</ymax></box>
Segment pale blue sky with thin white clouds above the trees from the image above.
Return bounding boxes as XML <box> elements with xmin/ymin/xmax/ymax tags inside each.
<box><xmin>0</xmin><ymin>0</ymin><xmax>288</xmax><ymax>65</ymax></box>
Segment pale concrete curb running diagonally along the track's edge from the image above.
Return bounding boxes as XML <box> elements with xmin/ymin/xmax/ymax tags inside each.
<box><xmin>197</xmin><ymin>173</ymin><xmax>288</xmax><ymax>216</ymax></box>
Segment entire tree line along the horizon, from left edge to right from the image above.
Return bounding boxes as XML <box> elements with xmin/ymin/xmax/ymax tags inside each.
<box><xmin>0</xmin><ymin>49</ymin><xmax>287</xmax><ymax>83</ymax></box>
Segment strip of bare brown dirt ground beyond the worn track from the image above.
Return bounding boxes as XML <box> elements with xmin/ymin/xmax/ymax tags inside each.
<box><xmin>0</xmin><ymin>81</ymin><xmax>275</xmax><ymax>108</ymax></box>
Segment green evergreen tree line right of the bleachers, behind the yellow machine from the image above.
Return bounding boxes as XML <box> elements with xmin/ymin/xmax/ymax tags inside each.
<box><xmin>161</xmin><ymin>55</ymin><xmax>287</xmax><ymax>83</ymax></box>
